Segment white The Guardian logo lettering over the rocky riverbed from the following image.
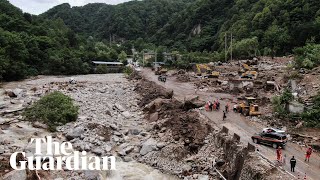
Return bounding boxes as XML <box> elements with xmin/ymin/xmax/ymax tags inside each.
<box><xmin>10</xmin><ymin>136</ymin><xmax>116</xmax><ymax>170</ymax></box>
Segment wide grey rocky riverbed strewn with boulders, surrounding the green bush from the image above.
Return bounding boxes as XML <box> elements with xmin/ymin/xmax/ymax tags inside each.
<box><xmin>0</xmin><ymin>74</ymin><xmax>176</xmax><ymax>180</ymax></box>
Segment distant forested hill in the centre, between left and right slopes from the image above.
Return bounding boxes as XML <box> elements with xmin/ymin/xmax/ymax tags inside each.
<box><xmin>41</xmin><ymin>0</ymin><xmax>194</xmax><ymax>40</ymax></box>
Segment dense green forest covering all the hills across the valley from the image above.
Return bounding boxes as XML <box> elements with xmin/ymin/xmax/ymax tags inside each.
<box><xmin>0</xmin><ymin>0</ymin><xmax>320</xmax><ymax>80</ymax></box>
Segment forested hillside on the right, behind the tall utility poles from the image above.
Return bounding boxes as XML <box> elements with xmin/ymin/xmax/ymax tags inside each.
<box><xmin>154</xmin><ymin>0</ymin><xmax>320</xmax><ymax>55</ymax></box>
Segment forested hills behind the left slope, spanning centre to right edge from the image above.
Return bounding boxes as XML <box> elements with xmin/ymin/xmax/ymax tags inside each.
<box><xmin>43</xmin><ymin>0</ymin><xmax>320</xmax><ymax>57</ymax></box>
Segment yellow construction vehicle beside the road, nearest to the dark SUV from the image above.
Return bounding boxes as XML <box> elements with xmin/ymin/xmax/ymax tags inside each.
<box><xmin>237</xmin><ymin>97</ymin><xmax>261</xmax><ymax>116</ymax></box>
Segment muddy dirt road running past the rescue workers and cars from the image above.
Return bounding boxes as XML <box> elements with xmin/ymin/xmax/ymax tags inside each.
<box><xmin>141</xmin><ymin>69</ymin><xmax>320</xmax><ymax>180</ymax></box>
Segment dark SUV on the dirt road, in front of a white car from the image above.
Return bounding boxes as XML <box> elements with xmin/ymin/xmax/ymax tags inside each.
<box><xmin>251</xmin><ymin>133</ymin><xmax>287</xmax><ymax>148</ymax></box>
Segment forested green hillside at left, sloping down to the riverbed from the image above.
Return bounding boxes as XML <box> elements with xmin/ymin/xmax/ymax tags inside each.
<box><xmin>0</xmin><ymin>0</ymin><xmax>131</xmax><ymax>81</ymax></box>
